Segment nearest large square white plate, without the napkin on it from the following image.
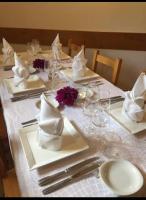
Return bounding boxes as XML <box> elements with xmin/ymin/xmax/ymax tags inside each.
<box><xmin>19</xmin><ymin>118</ymin><xmax>89</xmax><ymax>170</ymax></box>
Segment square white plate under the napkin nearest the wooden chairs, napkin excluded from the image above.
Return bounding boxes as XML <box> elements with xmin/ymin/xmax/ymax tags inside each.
<box><xmin>61</xmin><ymin>68</ymin><xmax>100</xmax><ymax>83</ymax></box>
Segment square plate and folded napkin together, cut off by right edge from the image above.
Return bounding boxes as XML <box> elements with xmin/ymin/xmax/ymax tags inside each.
<box><xmin>110</xmin><ymin>73</ymin><xmax>146</xmax><ymax>134</ymax></box>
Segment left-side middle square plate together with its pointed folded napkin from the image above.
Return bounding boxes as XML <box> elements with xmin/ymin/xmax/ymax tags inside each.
<box><xmin>4</xmin><ymin>53</ymin><xmax>47</xmax><ymax>101</ymax></box>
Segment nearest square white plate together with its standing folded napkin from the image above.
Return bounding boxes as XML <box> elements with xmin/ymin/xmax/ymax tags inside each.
<box><xmin>19</xmin><ymin>94</ymin><xmax>89</xmax><ymax>170</ymax></box>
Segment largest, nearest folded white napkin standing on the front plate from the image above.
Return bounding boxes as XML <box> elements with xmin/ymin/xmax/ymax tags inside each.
<box><xmin>36</xmin><ymin>94</ymin><xmax>64</xmax><ymax>150</ymax></box>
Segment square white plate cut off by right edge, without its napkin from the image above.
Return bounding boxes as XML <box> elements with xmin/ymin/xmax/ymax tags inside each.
<box><xmin>111</xmin><ymin>101</ymin><xmax>146</xmax><ymax>134</ymax></box>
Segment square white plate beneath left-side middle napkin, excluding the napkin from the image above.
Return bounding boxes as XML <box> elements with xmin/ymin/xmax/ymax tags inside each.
<box><xmin>4</xmin><ymin>75</ymin><xmax>46</xmax><ymax>95</ymax></box>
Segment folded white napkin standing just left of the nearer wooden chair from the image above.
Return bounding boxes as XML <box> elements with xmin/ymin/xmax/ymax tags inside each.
<box><xmin>72</xmin><ymin>46</ymin><xmax>87</xmax><ymax>78</ymax></box>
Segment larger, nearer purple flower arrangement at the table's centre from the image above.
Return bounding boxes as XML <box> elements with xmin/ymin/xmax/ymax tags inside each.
<box><xmin>56</xmin><ymin>86</ymin><xmax>78</xmax><ymax>106</ymax></box>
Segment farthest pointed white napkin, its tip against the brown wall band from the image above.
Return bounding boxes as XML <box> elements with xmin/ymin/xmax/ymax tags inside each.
<box><xmin>51</xmin><ymin>33</ymin><xmax>62</xmax><ymax>60</ymax></box>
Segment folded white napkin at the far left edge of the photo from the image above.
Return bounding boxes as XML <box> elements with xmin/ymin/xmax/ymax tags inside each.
<box><xmin>2</xmin><ymin>38</ymin><xmax>14</xmax><ymax>64</ymax></box>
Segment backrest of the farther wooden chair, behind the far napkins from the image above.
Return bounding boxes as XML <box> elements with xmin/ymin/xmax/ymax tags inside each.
<box><xmin>68</xmin><ymin>39</ymin><xmax>85</xmax><ymax>57</ymax></box>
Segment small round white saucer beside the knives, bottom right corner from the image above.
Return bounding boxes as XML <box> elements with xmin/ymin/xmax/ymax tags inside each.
<box><xmin>99</xmin><ymin>160</ymin><xmax>144</xmax><ymax>195</ymax></box>
